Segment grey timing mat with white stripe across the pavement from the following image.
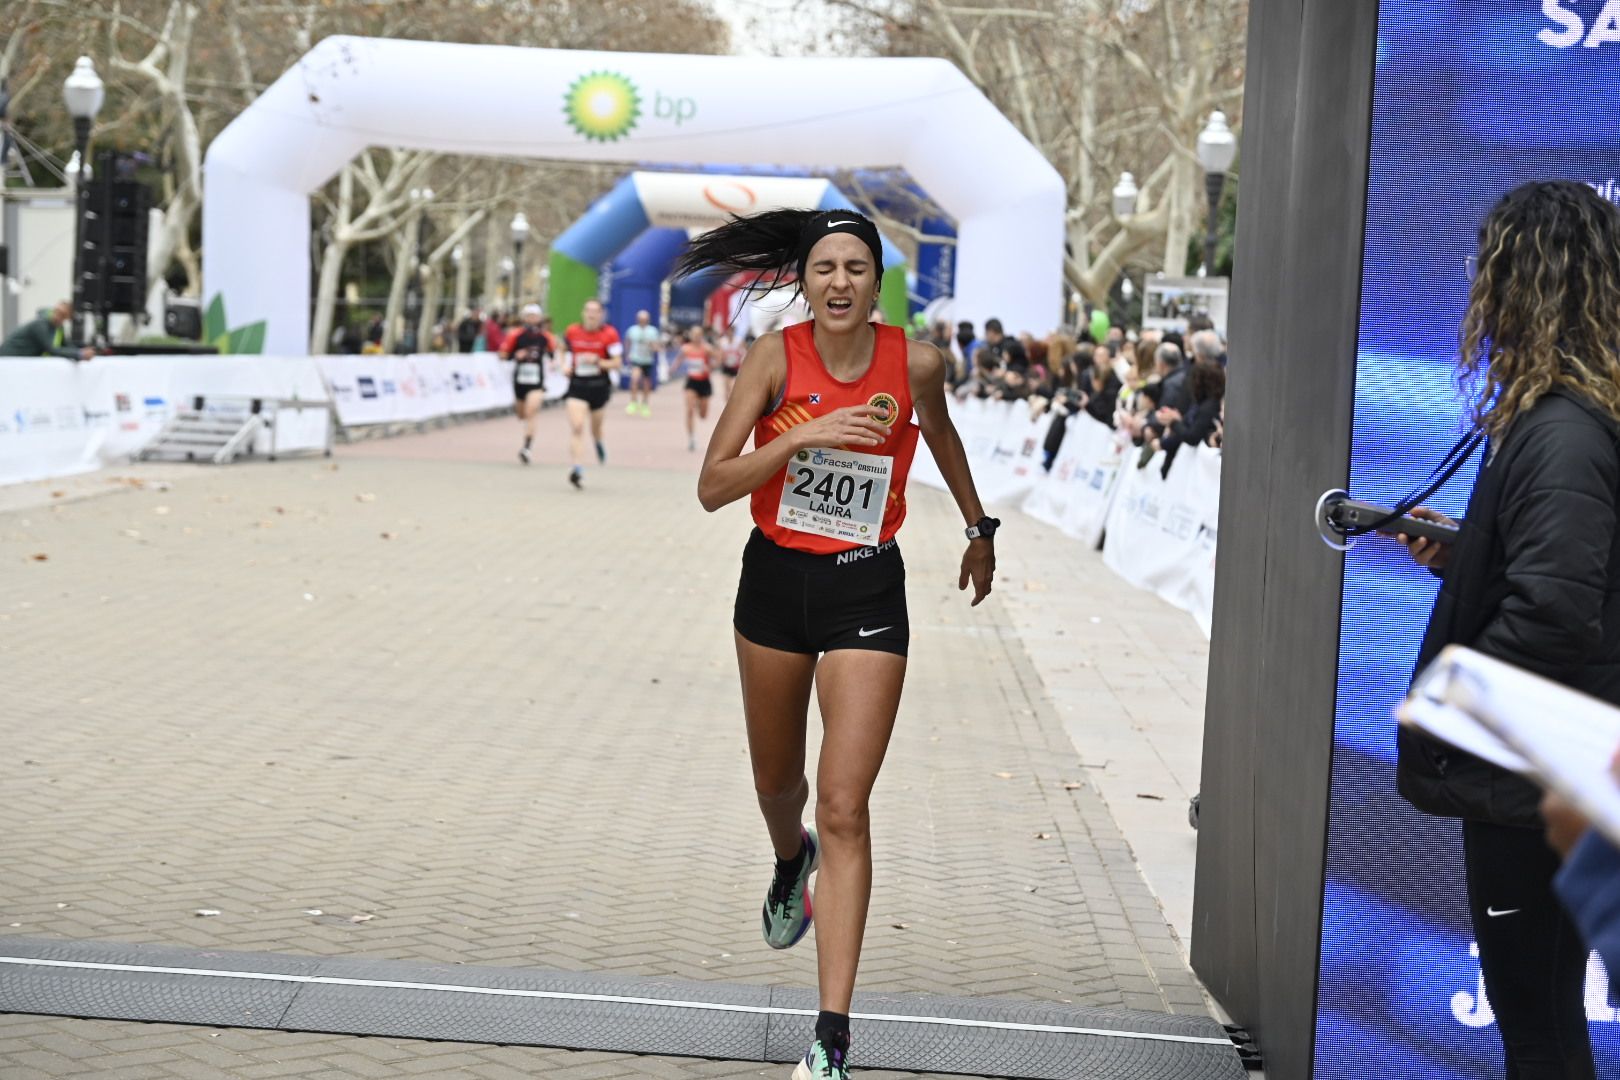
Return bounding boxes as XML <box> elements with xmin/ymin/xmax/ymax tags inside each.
<box><xmin>0</xmin><ymin>936</ymin><xmax>1246</xmax><ymax>1080</ymax></box>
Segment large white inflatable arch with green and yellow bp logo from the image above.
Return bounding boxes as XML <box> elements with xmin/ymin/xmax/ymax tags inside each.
<box><xmin>203</xmin><ymin>37</ymin><xmax>1064</xmax><ymax>355</ymax></box>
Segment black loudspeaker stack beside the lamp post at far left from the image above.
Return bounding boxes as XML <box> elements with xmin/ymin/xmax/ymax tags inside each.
<box><xmin>79</xmin><ymin>151</ymin><xmax>152</xmax><ymax>316</ymax></box>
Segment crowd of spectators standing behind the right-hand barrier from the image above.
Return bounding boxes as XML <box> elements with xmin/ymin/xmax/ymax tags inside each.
<box><xmin>939</xmin><ymin>307</ymin><xmax>1226</xmax><ymax>473</ymax></box>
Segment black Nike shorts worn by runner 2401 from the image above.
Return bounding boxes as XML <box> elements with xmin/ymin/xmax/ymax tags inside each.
<box><xmin>732</xmin><ymin>529</ymin><xmax>910</xmax><ymax>656</ymax></box>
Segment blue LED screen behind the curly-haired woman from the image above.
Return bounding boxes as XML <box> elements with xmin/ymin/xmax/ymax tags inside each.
<box><xmin>1321</xmin><ymin>0</ymin><xmax>1620</xmax><ymax>1080</ymax></box>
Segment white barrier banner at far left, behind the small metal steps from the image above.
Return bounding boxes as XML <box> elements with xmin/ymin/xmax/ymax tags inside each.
<box><xmin>0</xmin><ymin>356</ymin><xmax>327</xmax><ymax>484</ymax></box>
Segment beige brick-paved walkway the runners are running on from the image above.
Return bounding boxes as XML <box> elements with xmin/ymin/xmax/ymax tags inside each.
<box><xmin>0</xmin><ymin>383</ymin><xmax>1207</xmax><ymax>1078</ymax></box>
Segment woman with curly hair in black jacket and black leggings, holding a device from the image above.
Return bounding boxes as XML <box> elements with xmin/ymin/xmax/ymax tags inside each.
<box><xmin>1398</xmin><ymin>181</ymin><xmax>1620</xmax><ymax>1080</ymax></box>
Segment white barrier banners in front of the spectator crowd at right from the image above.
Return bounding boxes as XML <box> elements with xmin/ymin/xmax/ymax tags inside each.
<box><xmin>910</xmin><ymin>400</ymin><xmax>1221</xmax><ymax>635</ymax></box>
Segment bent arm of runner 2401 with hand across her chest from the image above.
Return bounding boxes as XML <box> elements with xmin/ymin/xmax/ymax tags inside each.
<box><xmin>698</xmin><ymin>334</ymin><xmax>888</xmax><ymax>513</ymax></box>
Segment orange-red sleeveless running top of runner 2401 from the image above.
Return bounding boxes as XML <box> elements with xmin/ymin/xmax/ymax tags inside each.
<box><xmin>748</xmin><ymin>322</ymin><xmax>917</xmax><ymax>555</ymax></box>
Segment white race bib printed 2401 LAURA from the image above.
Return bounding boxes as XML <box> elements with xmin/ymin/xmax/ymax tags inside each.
<box><xmin>776</xmin><ymin>449</ymin><xmax>894</xmax><ymax>547</ymax></box>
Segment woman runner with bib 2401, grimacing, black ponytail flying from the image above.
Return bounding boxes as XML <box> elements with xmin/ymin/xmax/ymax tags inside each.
<box><xmin>679</xmin><ymin>210</ymin><xmax>1000</xmax><ymax>1080</ymax></box>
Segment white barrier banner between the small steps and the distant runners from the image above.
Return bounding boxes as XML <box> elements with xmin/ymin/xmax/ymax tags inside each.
<box><xmin>314</xmin><ymin>353</ymin><xmax>518</xmax><ymax>427</ymax></box>
